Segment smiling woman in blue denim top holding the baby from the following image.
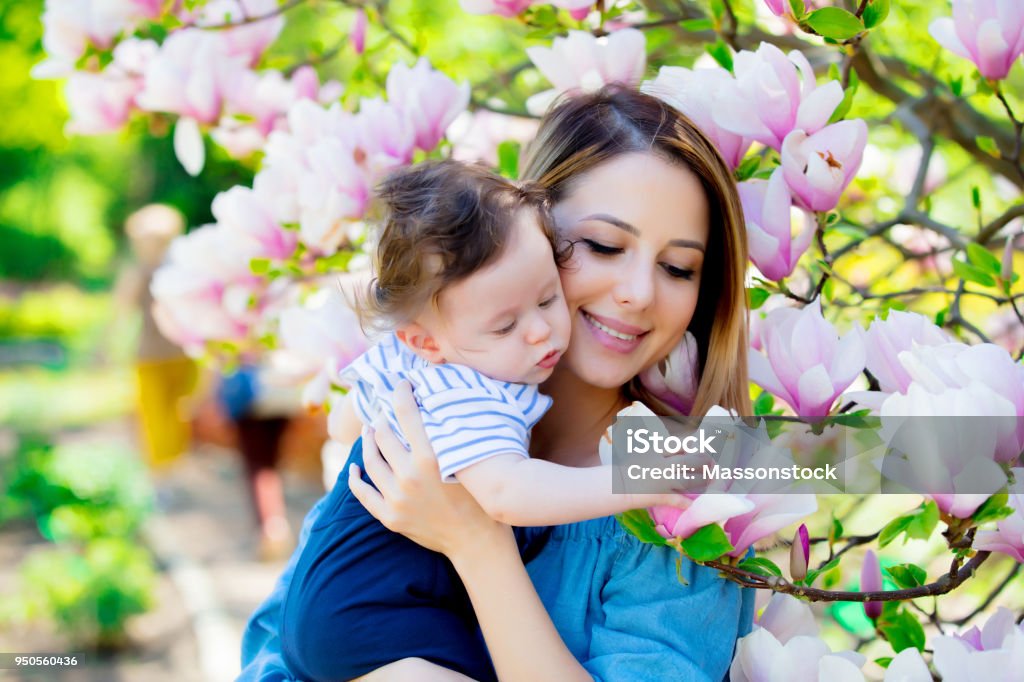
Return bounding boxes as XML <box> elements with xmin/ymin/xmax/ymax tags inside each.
<box><xmin>237</xmin><ymin>88</ymin><xmax>753</xmax><ymax>682</ymax></box>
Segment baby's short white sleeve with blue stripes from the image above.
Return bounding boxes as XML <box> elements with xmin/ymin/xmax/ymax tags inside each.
<box><xmin>419</xmin><ymin>388</ymin><xmax>529</xmax><ymax>482</ymax></box>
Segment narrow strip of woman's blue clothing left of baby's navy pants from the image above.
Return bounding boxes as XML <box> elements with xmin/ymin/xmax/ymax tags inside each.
<box><xmin>238</xmin><ymin>494</ymin><xmax>330</xmax><ymax>682</ymax></box>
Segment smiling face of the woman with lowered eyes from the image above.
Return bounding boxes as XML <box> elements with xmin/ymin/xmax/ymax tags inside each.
<box><xmin>553</xmin><ymin>153</ymin><xmax>709</xmax><ymax>388</ymax></box>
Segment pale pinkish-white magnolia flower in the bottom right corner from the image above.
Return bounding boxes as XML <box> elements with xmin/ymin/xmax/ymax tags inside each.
<box><xmin>932</xmin><ymin>606</ymin><xmax>1024</xmax><ymax>682</ymax></box>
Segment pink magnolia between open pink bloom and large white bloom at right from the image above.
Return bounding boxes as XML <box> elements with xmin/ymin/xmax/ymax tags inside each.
<box><xmin>864</xmin><ymin>310</ymin><xmax>952</xmax><ymax>393</ymax></box>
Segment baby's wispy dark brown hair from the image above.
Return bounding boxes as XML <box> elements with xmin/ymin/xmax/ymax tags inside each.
<box><xmin>355</xmin><ymin>160</ymin><xmax>567</xmax><ymax>331</ymax></box>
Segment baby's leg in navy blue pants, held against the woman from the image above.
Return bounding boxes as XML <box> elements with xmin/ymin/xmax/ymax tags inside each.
<box><xmin>281</xmin><ymin>438</ymin><xmax>496</xmax><ymax>682</ymax></box>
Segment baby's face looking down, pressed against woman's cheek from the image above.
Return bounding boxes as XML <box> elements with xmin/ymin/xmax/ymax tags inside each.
<box><xmin>424</xmin><ymin>210</ymin><xmax>569</xmax><ymax>384</ymax></box>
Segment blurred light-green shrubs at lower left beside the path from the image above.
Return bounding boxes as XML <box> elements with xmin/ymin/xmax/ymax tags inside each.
<box><xmin>0</xmin><ymin>436</ymin><xmax>156</xmax><ymax>649</ymax></box>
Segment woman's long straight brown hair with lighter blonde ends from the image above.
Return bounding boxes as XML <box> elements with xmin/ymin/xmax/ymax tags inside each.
<box><xmin>522</xmin><ymin>86</ymin><xmax>751</xmax><ymax>415</ymax></box>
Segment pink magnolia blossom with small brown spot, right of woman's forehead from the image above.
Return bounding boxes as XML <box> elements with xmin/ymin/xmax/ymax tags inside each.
<box><xmin>782</xmin><ymin>119</ymin><xmax>867</xmax><ymax>211</ymax></box>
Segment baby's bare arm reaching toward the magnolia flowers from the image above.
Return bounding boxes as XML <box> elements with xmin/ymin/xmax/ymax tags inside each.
<box><xmin>455</xmin><ymin>453</ymin><xmax>680</xmax><ymax>525</ymax></box>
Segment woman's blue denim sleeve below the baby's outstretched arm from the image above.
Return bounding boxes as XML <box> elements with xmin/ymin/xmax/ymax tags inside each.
<box><xmin>582</xmin><ymin>543</ymin><xmax>754</xmax><ymax>682</ymax></box>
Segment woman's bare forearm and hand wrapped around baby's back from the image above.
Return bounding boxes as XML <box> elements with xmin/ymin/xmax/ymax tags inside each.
<box><xmin>349</xmin><ymin>385</ymin><xmax>593</xmax><ymax>682</ymax></box>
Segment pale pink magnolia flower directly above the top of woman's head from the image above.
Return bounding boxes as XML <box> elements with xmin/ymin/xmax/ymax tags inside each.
<box><xmin>526</xmin><ymin>29</ymin><xmax>647</xmax><ymax>116</ymax></box>
